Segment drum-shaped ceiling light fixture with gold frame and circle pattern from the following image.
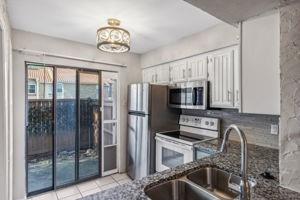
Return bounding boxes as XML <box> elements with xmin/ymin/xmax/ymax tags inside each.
<box><xmin>97</xmin><ymin>19</ymin><xmax>130</xmax><ymax>53</ymax></box>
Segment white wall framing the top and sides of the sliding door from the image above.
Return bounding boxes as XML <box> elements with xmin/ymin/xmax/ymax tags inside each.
<box><xmin>12</xmin><ymin>30</ymin><xmax>142</xmax><ymax>199</ymax></box>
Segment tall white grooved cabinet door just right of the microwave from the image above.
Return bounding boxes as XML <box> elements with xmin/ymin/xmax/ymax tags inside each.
<box><xmin>208</xmin><ymin>49</ymin><xmax>234</xmax><ymax>108</ymax></box>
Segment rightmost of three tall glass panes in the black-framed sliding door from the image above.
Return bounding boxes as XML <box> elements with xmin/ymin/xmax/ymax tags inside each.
<box><xmin>79</xmin><ymin>71</ymin><xmax>100</xmax><ymax>179</ymax></box>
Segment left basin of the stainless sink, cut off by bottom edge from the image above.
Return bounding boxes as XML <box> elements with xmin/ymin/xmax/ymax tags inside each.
<box><xmin>145</xmin><ymin>179</ymin><xmax>219</xmax><ymax>200</ymax></box>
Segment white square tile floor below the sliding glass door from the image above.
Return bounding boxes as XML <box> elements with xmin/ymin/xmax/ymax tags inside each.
<box><xmin>29</xmin><ymin>174</ymin><xmax>131</xmax><ymax>200</ymax></box>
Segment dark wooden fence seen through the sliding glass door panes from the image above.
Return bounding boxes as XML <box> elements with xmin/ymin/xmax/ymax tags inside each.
<box><xmin>26</xmin><ymin>99</ymin><xmax>99</xmax><ymax>158</ymax></box>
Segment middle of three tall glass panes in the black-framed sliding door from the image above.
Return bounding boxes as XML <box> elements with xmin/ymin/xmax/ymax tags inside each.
<box><xmin>56</xmin><ymin>68</ymin><xmax>77</xmax><ymax>186</ymax></box>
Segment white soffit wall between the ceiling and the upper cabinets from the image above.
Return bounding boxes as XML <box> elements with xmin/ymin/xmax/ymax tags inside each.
<box><xmin>141</xmin><ymin>23</ymin><xmax>239</xmax><ymax>67</ymax></box>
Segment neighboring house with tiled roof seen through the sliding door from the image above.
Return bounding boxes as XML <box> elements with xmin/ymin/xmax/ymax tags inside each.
<box><xmin>27</xmin><ymin>66</ymin><xmax>99</xmax><ymax>99</ymax></box>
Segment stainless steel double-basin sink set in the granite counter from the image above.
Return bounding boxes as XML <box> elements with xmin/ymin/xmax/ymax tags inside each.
<box><xmin>145</xmin><ymin>167</ymin><xmax>256</xmax><ymax>200</ymax></box>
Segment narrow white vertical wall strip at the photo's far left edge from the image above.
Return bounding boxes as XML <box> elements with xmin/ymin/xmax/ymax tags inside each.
<box><xmin>0</xmin><ymin>0</ymin><xmax>13</xmax><ymax>200</ymax></box>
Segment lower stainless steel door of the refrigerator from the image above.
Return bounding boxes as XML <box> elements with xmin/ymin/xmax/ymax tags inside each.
<box><xmin>127</xmin><ymin>114</ymin><xmax>150</xmax><ymax>179</ymax></box>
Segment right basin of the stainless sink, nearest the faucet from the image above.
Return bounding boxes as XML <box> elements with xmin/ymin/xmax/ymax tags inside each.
<box><xmin>187</xmin><ymin>167</ymin><xmax>255</xmax><ymax>199</ymax></box>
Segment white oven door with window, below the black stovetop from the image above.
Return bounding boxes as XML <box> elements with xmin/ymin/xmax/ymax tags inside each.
<box><xmin>155</xmin><ymin>137</ymin><xmax>193</xmax><ymax>172</ymax></box>
